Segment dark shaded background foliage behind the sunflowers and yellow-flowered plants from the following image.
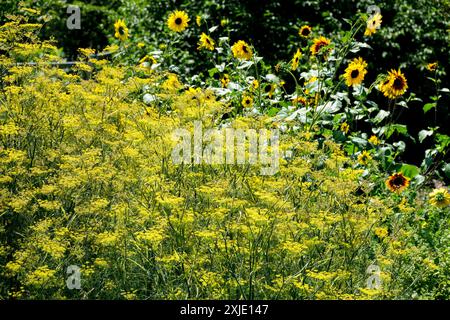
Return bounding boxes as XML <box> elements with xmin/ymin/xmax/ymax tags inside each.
<box><xmin>0</xmin><ymin>0</ymin><xmax>450</xmax><ymax>164</ymax></box>
